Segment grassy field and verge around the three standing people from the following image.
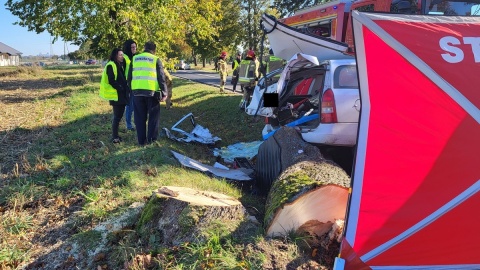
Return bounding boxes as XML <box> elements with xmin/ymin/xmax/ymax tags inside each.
<box><xmin>0</xmin><ymin>66</ymin><xmax>326</xmax><ymax>269</ymax></box>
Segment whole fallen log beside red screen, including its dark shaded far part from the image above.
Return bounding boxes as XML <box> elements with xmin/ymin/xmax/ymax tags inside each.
<box><xmin>264</xmin><ymin>127</ymin><xmax>350</xmax><ymax>237</ymax></box>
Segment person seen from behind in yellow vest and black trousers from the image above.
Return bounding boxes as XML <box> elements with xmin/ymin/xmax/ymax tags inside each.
<box><xmin>128</xmin><ymin>41</ymin><xmax>167</xmax><ymax>146</ymax></box>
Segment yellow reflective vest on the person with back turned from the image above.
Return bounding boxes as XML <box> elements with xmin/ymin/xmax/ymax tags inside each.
<box><xmin>132</xmin><ymin>52</ymin><xmax>160</xmax><ymax>92</ymax></box>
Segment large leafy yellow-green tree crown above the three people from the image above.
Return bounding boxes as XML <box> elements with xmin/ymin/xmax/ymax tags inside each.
<box><xmin>5</xmin><ymin>0</ymin><xmax>219</xmax><ymax>58</ymax></box>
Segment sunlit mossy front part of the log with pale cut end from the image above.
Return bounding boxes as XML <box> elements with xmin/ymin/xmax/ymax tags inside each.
<box><xmin>264</xmin><ymin>160</ymin><xmax>350</xmax><ymax>237</ymax></box>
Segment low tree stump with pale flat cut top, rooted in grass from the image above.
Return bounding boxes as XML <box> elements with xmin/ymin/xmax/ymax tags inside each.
<box><xmin>137</xmin><ymin>186</ymin><xmax>248</xmax><ymax>246</ymax></box>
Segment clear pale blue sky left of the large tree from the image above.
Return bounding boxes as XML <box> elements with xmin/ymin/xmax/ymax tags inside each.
<box><xmin>0</xmin><ymin>0</ymin><xmax>78</xmax><ymax>56</ymax></box>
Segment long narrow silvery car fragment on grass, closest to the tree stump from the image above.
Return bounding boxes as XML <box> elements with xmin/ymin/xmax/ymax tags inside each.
<box><xmin>170</xmin><ymin>150</ymin><xmax>252</xmax><ymax>181</ymax></box>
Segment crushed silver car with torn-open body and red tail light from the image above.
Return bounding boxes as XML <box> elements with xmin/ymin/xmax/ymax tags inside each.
<box><xmin>246</xmin><ymin>53</ymin><xmax>360</xmax><ymax>146</ymax></box>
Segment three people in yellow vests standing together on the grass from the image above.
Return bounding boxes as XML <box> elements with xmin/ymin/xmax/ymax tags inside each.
<box><xmin>100</xmin><ymin>40</ymin><xmax>172</xmax><ymax>146</ymax></box>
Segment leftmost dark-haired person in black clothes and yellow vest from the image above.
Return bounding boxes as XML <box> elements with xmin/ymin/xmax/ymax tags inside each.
<box><xmin>99</xmin><ymin>48</ymin><xmax>130</xmax><ymax>143</ymax></box>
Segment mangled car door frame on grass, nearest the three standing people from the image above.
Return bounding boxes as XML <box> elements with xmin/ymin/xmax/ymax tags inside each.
<box><xmin>162</xmin><ymin>113</ymin><xmax>221</xmax><ymax>144</ymax></box>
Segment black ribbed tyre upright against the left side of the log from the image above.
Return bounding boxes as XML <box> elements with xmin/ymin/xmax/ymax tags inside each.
<box><xmin>255</xmin><ymin>136</ymin><xmax>282</xmax><ymax>194</ymax></box>
